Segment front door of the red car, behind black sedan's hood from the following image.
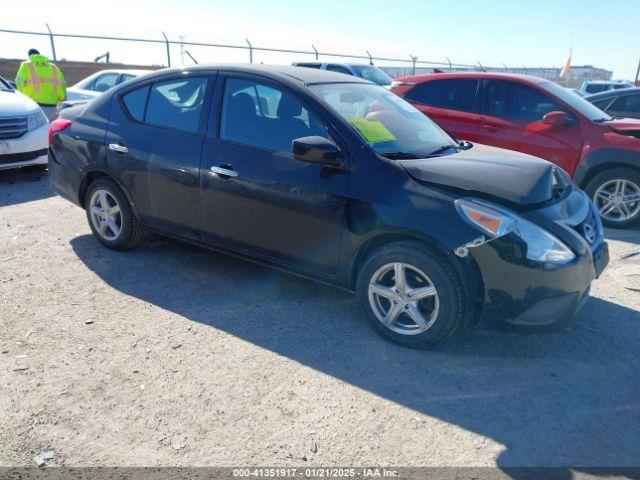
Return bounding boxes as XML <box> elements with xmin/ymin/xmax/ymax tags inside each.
<box><xmin>478</xmin><ymin>80</ymin><xmax>582</xmax><ymax>173</ymax></box>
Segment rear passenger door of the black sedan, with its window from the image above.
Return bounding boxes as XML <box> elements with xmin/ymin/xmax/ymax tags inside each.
<box><xmin>106</xmin><ymin>72</ymin><xmax>215</xmax><ymax>237</ymax></box>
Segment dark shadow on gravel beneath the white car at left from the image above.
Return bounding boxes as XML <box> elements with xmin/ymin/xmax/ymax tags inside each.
<box><xmin>0</xmin><ymin>168</ymin><xmax>54</xmax><ymax>207</ymax></box>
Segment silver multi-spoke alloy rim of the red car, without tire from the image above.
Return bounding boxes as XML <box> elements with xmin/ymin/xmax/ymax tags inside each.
<box><xmin>593</xmin><ymin>179</ymin><xmax>640</xmax><ymax>222</ymax></box>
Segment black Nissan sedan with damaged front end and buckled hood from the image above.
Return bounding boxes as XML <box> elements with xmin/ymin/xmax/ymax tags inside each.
<box><xmin>49</xmin><ymin>65</ymin><xmax>608</xmax><ymax>346</ymax></box>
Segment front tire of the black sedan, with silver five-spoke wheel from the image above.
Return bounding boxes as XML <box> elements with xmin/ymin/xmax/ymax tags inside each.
<box><xmin>356</xmin><ymin>242</ymin><xmax>466</xmax><ymax>348</ymax></box>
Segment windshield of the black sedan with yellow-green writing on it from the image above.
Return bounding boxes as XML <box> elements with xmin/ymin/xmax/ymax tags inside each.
<box><xmin>309</xmin><ymin>83</ymin><xmax>458</xmax><ymax>158</ymax></box>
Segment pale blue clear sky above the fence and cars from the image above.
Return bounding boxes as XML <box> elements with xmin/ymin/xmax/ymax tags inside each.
<box><xmin>0</xmin><ymin>0</ymin><xmax>640</xmax><ymax>79</ymax></box>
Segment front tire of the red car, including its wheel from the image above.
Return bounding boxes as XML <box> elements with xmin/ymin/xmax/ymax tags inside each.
<box><xmin>585</xmin><ymin>168</ymin><xmax>640</xmax><ymax>228</ymax></box>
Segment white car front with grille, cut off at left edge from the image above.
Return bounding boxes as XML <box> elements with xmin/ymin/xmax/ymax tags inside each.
<box><xmin>0</xmin><ymin>77</ymin><xmax>49</xmax><ymax>170</ymax></box>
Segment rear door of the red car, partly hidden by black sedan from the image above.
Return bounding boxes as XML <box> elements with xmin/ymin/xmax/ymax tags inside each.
<box><xmin>405</xmin><ymin>78</ymin><xmax>479</xmax><ymax>142</ymax></box>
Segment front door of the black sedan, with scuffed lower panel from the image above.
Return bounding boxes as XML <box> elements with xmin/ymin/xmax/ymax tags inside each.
<box><xmin>200</xmin><ymin>76</ymin><xmax>348</xmax><ymax>275</ymax></box>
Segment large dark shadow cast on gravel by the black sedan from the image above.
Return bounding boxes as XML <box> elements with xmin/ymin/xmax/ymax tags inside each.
<box><xmin>71</xmin><ymin>235</ymin><xmax>640</xmax><ymax>478</ymax></box>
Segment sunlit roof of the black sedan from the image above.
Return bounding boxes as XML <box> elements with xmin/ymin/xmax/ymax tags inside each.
<box><xmin>139</xmin><ymin>63</ymin><xmax>374</xmax><ymax>85</ymax></box>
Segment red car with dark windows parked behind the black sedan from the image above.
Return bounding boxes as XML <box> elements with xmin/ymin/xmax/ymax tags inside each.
<box><xmin>391</xmin><ymin>72</ymin><xmax>640</xmax><ymax>227</ymax></box>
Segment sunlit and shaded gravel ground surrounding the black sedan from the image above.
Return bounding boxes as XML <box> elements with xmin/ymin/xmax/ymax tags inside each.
<box><xmin>0</xmin><ymin>172</ymin><xmax>640</xmax><ymax>466</ymax></box>
